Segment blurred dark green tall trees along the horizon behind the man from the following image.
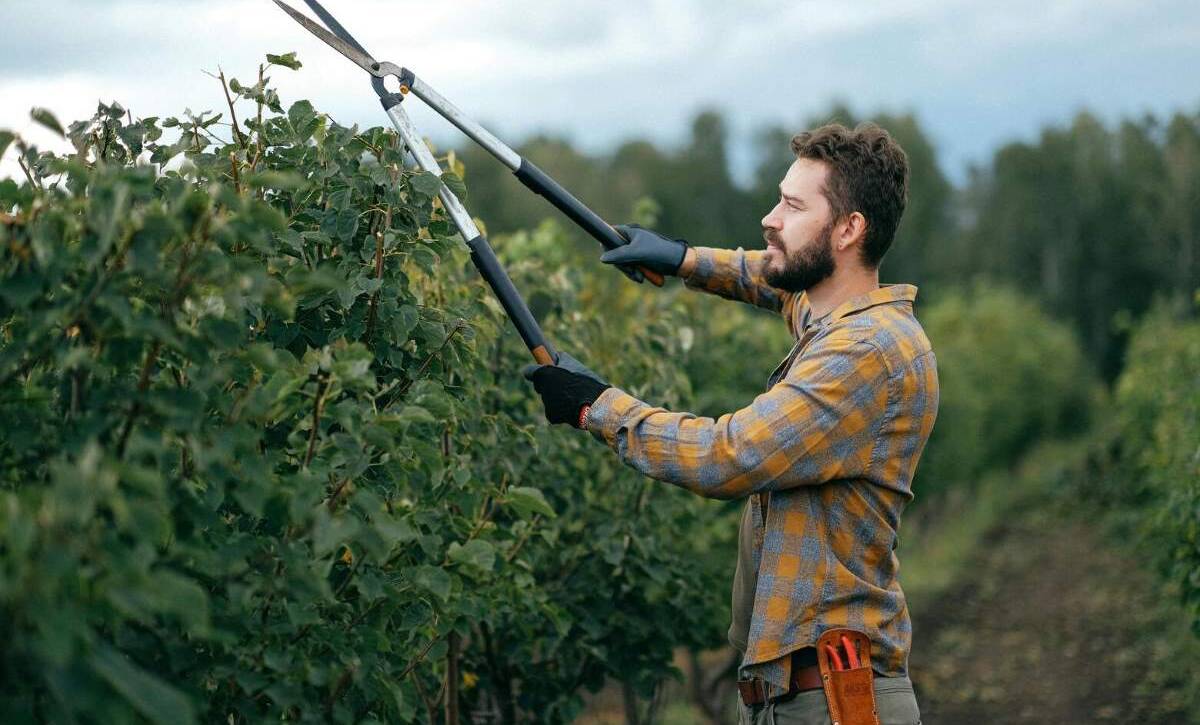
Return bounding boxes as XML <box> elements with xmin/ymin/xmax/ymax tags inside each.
<box><xmin>460</xmin><ymin>104</ymin><xmax>1200</xmax><ymax>381</ymax></box>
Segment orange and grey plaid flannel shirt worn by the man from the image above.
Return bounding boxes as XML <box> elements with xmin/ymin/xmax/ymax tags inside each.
<box><xmin>588</xmin><ymin>247</ymin><xmax>938</xmax><ymax>694</ymax></box>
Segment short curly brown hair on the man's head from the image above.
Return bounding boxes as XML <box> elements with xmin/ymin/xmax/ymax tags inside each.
<box><xmin>792</xmin><ymin>124</ymin><xmax>908</xmax><ymax>269</ymax></box>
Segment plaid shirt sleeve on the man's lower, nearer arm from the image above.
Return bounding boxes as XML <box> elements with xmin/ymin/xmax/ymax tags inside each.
<box><xmin>588</xmin><ymin>338</ymin><xmax>889</xmax><ymax>498</ymax></box>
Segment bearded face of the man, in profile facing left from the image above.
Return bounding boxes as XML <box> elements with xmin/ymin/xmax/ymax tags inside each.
<box><xmin>762</xmin><ymin>158</ymin><xmax>836</xmax><ymax>292</ymax></box>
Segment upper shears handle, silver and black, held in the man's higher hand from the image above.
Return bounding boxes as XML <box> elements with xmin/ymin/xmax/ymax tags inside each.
<box><xmin>401</xmin><ymin>72</ymin><xmax>662</xmax><ymax>287</ymax></box>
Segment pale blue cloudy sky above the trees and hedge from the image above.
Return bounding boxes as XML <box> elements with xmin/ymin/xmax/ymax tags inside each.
<box><xmin>0</xmin><ymin>0</ymin><xmax>1200</xmax><ymax>179</ymax></box>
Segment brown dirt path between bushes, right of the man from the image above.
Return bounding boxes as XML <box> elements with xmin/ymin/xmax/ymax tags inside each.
<box><xmin>910</xmin><ymin>505</ymin><xmax>1200</xmax><ymax>725</ymax></box>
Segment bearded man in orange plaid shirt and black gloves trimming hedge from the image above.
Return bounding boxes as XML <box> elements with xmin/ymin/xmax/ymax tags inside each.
<box><xmin>526</xmin><ymin>124</ymin><xmax>938</xmax><ymax>725</ymax></box>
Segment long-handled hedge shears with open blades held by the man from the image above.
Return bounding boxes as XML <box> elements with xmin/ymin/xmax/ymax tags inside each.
<box><xmin>274</xmin><ymin>0</ymin><xmax>662</xmax><ymax>365</ymax></box>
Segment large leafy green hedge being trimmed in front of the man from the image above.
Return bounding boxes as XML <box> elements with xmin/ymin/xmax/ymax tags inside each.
<box><xmin>0</xmin><ymin>63</ymin><xmax>727</xmax><ymax>723</ymax></box>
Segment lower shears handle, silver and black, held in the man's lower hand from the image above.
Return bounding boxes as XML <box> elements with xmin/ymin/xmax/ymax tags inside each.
<box><xmin>384</xmin><ymin>100</ymin><xmax>558</xmax><ymax>365</ymax></box>
